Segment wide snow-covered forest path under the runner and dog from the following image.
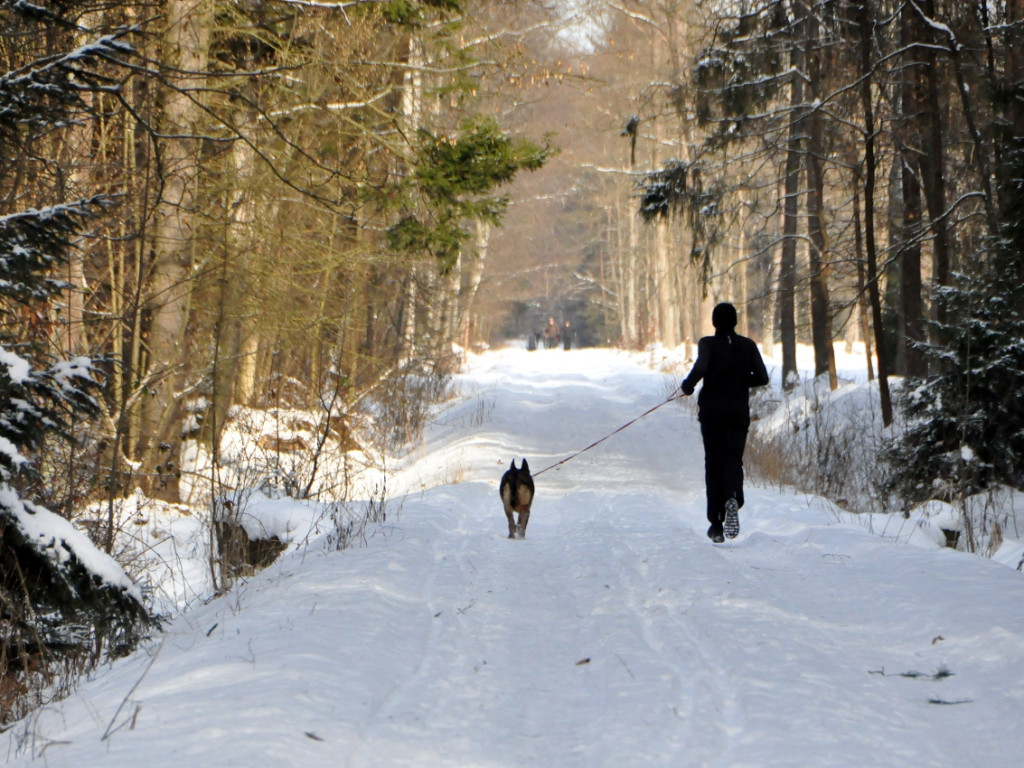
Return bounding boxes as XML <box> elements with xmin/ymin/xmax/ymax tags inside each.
<box><xmin>5</xmin><ymin>349</ymin><xmax>1024</xmax><ymax>768</ymax></box>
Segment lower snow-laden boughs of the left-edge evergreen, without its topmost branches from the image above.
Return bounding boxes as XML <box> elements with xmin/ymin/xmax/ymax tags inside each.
<box><xmin>0</xmin><ymin>205</ymin><xmax>148</xmax><ymax>696</ymax></box>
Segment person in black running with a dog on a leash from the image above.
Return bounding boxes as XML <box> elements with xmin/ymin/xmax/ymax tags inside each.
<box><xmin>681</xmin><ymin>303</ymin><xmax>768</xmax><ymax>543</ymax></box>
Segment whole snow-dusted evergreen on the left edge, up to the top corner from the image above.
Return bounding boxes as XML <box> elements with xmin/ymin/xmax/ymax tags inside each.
<box><xmin>0</xmin><ymin>2</ymin><xmax>148</xmax><ymax>696</ymax></box>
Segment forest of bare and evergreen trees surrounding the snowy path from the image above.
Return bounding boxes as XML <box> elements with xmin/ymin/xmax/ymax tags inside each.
<box><xmin>0</xmin><ymin>0</ymin><xmax>1024</xmax><ymax>729</ymax></box>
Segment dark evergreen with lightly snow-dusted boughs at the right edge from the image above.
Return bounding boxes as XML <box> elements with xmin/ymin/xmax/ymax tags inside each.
<box><xmin>890</xmin><ymin>139</ymin><xmax>1024</xmax><ymax>502</ymax></box>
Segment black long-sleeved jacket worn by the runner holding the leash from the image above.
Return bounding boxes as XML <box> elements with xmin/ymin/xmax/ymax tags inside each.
<box><xmin>682</xmin><ymin>330</ymin><xmax>768</xmax><ymax>423</ymax></box>
